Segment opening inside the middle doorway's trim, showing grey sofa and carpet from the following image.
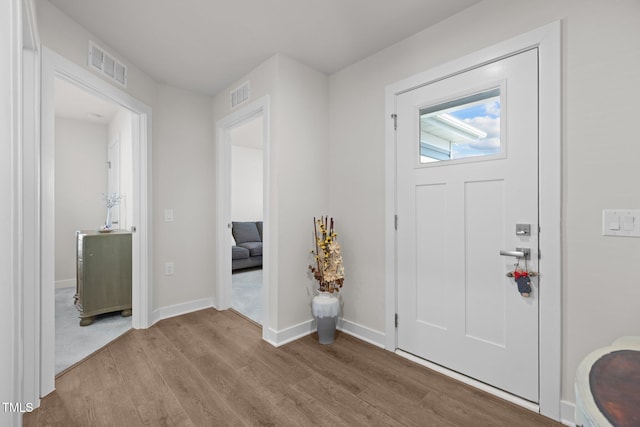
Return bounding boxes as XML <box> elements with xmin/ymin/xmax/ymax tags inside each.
<box><xmin>229</xmin><ymin>114</ymin><xmax>264</xmax><ymax>325</ymax></box>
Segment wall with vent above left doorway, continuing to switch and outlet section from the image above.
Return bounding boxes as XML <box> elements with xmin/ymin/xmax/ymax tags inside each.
<box><xmin>37</xmin><ymin>1</ymin><xmax>215</xmax><ymax>310</ymax></box>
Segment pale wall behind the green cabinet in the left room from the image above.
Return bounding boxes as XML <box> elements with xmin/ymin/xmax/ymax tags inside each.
<box><xmin>55</xmin><ymin>117</ymin><xmax>108</xmax><ymax>286</ymax></box>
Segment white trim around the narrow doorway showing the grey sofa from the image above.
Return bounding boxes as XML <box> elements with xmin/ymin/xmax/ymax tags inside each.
<box><xmin>214</xmin><ymin>95</ymin><xmax>273</xmax><ymax>341</ymax></box>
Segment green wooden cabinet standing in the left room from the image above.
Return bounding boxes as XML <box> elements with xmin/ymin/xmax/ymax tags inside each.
<box><xmin>75</xmin><ymin>230</ymin><xmax>131</xmax><ymax>326</ymax></box>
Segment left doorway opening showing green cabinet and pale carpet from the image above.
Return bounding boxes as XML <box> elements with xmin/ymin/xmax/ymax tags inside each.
<box><xmin>54</xmin><ymin>78</ymin><xmax>133</xmax><ymax>375</ymax></box>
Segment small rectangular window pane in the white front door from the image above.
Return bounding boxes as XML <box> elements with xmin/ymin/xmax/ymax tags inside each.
<box><xmin>420</xmin><ymin>88</ymin><xmax>500</xmax><ymax>163</ymax></box>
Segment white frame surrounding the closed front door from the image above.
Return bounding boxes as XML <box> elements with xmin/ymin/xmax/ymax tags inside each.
<box><xmin>385</xmin><ymin>21</ymin><xmax>562</xmax><ymax>420</ymax></box>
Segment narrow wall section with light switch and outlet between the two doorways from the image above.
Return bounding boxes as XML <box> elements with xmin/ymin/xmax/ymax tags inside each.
<box><xmin>153</xmin><ymin>85</ymin><xmax>215</xmax><ymax>307</ymax></box>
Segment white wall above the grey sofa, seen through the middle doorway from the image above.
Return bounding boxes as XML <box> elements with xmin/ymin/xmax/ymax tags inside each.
<box><xmin>231</xmin><ymin>145</ymin><xmax>263</xmax><ymax>221</ymax></box>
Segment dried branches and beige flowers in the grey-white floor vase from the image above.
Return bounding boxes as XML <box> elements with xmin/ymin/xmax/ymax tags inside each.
<box><xmin>309</xmin><ymin>216</ymin><xmax>344</xmax><ymax>293</ymax></box>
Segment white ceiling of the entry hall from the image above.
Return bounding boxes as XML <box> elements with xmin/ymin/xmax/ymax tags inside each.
<box><xmin>49</xmin><ymin>0</ymin><xmax>479</xmax><ymax>95</ymax></box>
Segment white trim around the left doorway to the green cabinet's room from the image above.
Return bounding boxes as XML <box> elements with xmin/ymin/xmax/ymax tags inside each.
<box><xmin>40</xmin><ymin>48</ymin><xmax>153</xmax><ymax>396</ymax></box>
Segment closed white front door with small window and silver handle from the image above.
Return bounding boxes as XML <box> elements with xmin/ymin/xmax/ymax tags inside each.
<box><xmin>396</xmin><ymin>49</ymin><xmax>539</xmax><ymax>402</ymax></box>
